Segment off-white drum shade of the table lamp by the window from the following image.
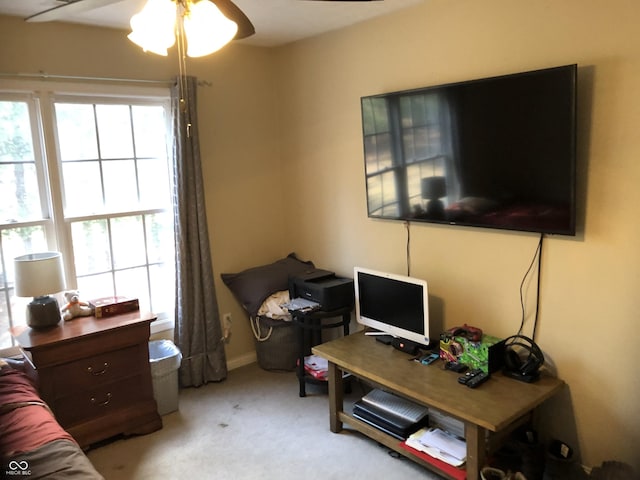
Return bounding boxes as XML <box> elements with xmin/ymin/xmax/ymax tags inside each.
<box><xmin>14</xmin><ymin>252</ymin><xmax>66</xmax><ymax>297</ymax></box>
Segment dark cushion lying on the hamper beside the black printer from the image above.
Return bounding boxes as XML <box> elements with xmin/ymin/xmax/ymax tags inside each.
<box><xmin>220</xmin><ymin>253</ymin><xmax>314</xmax><ymax>317</ymax></box>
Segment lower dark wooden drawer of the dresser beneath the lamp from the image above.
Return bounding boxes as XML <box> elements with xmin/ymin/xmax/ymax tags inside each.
<box><xmin>53</xmin><ymin>375</ymin><xmax>153</xmax><ymax>427</ymax></box>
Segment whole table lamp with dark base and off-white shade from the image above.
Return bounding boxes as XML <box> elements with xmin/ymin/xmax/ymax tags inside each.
<box><xmin>14</xmin><ymin>252</ymin><xmax>66</xmax><ymax>328</ymax></box>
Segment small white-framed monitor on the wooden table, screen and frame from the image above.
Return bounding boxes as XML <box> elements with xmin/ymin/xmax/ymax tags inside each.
<box><xmin>353</xmin><ymin>267</ymin><xmax>429</xmax><ymax>345</ymax></box>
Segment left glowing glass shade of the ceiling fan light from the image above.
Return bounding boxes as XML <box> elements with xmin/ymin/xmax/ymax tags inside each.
<box><xmin>127</xmin><ymin>0</ymin><xmax>176</xmax><ymax>56</ymax></box>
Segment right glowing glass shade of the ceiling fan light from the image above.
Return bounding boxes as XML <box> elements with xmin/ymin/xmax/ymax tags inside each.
<box><xmin>184</xmin><ymin>0</ymin><xmax>238</xmax><ymax>57</ymax></box>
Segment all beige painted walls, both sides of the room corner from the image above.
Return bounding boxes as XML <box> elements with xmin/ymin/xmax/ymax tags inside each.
<box><xmin>0</xmin><ymin>0</ymin><xmax>640</xmax><ymax>469</ymax></box>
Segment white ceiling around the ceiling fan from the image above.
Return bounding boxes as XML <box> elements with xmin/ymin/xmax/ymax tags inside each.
<box><xmin>0</xmin><ymin>0</ymin><xmax>425</xmax><ymax>47</ymax></box>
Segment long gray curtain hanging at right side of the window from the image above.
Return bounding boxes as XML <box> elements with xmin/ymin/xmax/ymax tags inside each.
<box><xmin>171</xmin><ymin>76</ymin><xmax>227</xmax><ymax>387</ymax></box>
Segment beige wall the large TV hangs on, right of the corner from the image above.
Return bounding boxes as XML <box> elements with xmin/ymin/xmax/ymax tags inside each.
<box><xmin>278</xmin><ymin>0</ymin><xmax>640</xmax><ymax>468</ymax></box>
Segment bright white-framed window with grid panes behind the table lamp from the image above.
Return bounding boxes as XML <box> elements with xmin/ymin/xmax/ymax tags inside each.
<box><xmin>0</xmin><ymin>80</ymin><xmax>175</xmax><ymax>348</ymax></box>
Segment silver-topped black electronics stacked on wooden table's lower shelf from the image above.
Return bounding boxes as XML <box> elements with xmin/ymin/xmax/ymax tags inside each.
<box><xmin>353</xmin><ymin>389</ymin><xmax>429</xmax><ymax>440</ymax></box>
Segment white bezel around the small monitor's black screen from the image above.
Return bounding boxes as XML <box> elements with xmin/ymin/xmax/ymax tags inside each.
<box><xmin>353</xmin><ymin>267</ymin><xmax>430</xmax><ymax>345</ymax></box>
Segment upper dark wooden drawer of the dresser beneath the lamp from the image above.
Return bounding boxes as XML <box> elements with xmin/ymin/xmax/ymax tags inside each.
<box><xmin>52</xmin><ymin>345</ymin><xmax>148</xmax><ymax>399</ymax></box>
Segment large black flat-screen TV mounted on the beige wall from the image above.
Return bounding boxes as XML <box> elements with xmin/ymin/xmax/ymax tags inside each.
<box><xmin>361</xmin><ymin>65</ymin><xmax>577</xmax><ymax>235</ymax></box>
